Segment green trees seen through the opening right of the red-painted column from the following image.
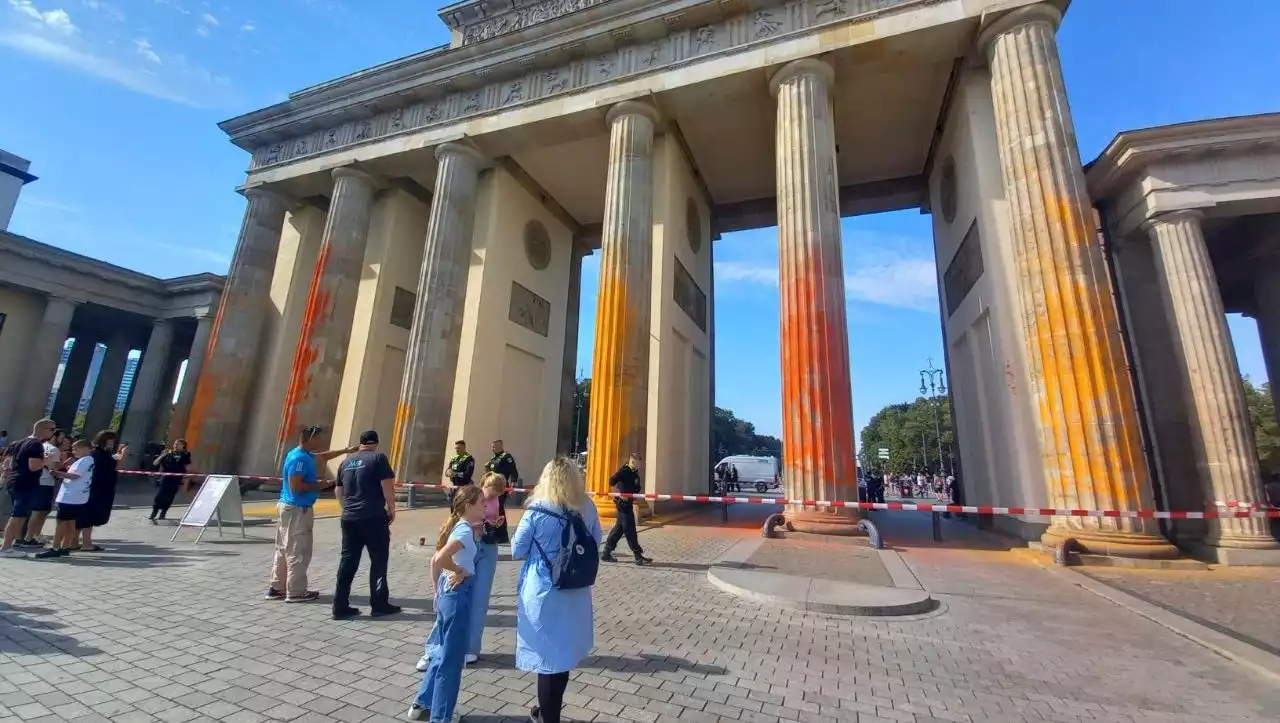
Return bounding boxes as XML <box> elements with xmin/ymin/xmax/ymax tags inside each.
<box><xmin>858</xmin><ymin>397</ymin><xmax>954</xmax><ymax>475</ymax></box>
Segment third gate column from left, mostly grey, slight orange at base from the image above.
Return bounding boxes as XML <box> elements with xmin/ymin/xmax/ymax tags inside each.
<box><xmin>390</xmin><ymin>143</ymin><xmax>484</xmax><ymax>480</ymax></box>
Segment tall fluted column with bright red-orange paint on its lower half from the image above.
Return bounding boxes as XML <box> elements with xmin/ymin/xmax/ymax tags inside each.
<box><xmin>769</xmin><ymin>58</ymin><xmax>858</xmax><ymax>535</ymax></box>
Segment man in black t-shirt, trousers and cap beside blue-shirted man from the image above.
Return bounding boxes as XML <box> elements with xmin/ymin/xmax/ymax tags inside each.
<box><xmin>333</xmin><ymin>430</ymin><xmax>401</xmax><ymax>621</ymax></box>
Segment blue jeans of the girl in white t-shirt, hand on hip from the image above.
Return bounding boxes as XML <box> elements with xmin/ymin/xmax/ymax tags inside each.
<box><xmin>415</xmin><ymin>575</ymin><xmax>475</xmax><ymax>723</ymax></box>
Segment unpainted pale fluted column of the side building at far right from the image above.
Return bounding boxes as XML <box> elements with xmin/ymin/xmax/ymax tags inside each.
<box><xmin>1147</xmin><ymin>211</ymin><xmax>1280</xmax><ymax>549</ymax></box>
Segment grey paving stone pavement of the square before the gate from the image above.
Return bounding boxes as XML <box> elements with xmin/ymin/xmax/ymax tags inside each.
<box><xmin>0</xmin><ymin>501</ymin><xmax>1280</xmax><ymax>723</ymax></box>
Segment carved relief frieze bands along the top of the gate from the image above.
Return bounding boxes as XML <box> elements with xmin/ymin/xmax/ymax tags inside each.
<box><xmin>241</xmin><ymin>0</ymin><xmax>921</xmax><ymax>170</ymax></box>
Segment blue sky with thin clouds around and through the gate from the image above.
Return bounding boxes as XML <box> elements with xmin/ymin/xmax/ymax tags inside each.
<box><xmin>0</xmin><ymin>0</ymin><xmax>1280</xmax><ymax>434</ymax></box>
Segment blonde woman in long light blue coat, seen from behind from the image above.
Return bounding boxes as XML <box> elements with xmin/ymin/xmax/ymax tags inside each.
<box><xmin>511</xmin><ymin>457</ymin><xmax>603</xmax><ymax>723</ymax></box>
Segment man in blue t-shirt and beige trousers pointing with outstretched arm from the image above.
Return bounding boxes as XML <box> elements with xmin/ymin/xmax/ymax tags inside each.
<box><xmin>266</xmin><ymin>426</ymin><xmax>358</xmax><ymax>603</ymax></box>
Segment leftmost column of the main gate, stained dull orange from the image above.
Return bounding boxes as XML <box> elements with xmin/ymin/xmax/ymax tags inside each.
<box><xmin>184</xmin><ymin>182</ymin><xmax>288</xmax><ymax>472</ymax></box>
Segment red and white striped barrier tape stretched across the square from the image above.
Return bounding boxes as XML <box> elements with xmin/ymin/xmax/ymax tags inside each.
<box><xmin>120</xmin><ymin>470</ymin><xmax>1280</xmax><ymax>520</ymax></box>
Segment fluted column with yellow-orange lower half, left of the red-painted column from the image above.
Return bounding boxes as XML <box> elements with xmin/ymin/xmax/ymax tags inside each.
<box><xmin>586</xmin><ymin>101</ymin><xmax>658</xmax><ymax>517</ymax></box>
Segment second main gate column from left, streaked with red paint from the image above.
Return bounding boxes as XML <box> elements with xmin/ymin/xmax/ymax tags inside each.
<box><xmin>276</xmin><ymin>168</ymin><xmax>376</xmax><ymax>452</ymax></box>
